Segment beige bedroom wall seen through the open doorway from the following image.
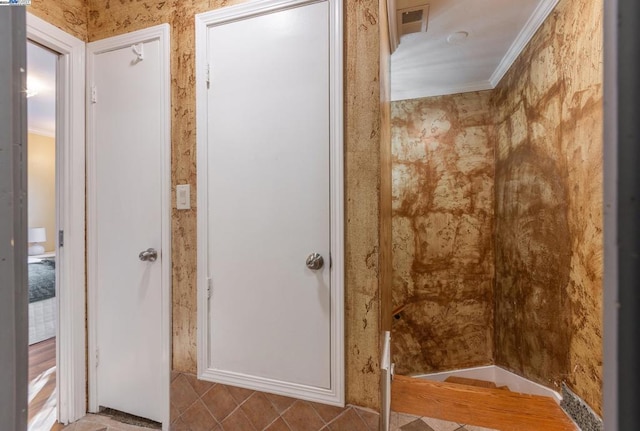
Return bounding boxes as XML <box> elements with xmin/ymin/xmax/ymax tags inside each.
<box><xmin>27</xmin><ymin>133</ymin><xmax>56</xmax><ymax>251</ymax></box>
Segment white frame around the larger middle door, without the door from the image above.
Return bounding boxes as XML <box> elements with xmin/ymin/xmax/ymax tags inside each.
<box><xmin>195</xmin><ymin>0</ymin><xmax>345</xmax><ymax>406</ymax></box>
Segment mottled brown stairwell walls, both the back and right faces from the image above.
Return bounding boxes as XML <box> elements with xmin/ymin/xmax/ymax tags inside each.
<box><xmin>392</xmin><ymin>0</ymin><xmax>603</xmax><ymax>414</ymax></box>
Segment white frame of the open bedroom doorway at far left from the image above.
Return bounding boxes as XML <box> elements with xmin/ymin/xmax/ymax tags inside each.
<box><xmin>27</xmin><ymin>13</ymin><xmax>86</xmax><ymax>424</ymax></box>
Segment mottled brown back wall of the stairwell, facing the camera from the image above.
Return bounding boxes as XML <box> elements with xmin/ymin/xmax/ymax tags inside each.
<box><xmin>391</xmin><ymin>91</ymin><xmax>495</xmax><ymax>374</ymax></box>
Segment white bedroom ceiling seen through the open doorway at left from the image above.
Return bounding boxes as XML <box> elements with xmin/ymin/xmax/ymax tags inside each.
<box><xmin>27</xmin><ymin>42</ymin><xmax>58</xmax><ymax>136</ymax></box>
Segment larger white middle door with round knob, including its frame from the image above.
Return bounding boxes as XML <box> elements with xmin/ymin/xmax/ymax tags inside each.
<box><xmin>196</xmin><ymin>0</ymin><xmax>344</xmax><ymax>405</ymax></box>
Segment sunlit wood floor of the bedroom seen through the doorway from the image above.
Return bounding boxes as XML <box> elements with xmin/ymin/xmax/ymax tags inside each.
<box><xmin>29</xmin><ymin>337</ymin><xmax>63</xmax><ymax>431</ymax></box>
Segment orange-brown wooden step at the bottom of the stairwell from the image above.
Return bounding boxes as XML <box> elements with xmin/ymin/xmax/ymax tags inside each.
<box><xmin>391</xmin><ymin>375</ymin><xmax>578</xmax><ymax>431</ymax></box>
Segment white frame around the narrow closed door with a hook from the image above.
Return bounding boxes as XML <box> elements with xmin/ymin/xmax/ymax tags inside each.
<box><xmin>86</xmin><ymin>24</ymin><xmax>171</xmax><ymax>430</ymax></box>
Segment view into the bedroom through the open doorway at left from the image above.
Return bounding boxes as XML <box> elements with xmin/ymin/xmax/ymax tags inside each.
<box><xmin>27</xmin><ymin>41</ymin><xmax>60</xmax><ymax>431</ymax></box>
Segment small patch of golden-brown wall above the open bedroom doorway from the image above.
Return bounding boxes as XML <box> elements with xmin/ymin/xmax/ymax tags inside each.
<box><xmin>27</xmin><ymin>0</ymin><xmax>87</xmax><ymax>41</ymax></box>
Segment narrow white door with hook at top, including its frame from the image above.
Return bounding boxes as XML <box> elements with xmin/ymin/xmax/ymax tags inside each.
<box><xmin>87</xmin><ymin>24</ymin><xmax>171</xmax><ymax>429</ymax></box>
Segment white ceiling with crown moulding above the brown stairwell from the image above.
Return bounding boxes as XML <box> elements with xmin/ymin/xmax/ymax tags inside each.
<box><xmin>390</xmin><ymin>0</ymin><xmax>558</xmax><ymax>100</ymax></box>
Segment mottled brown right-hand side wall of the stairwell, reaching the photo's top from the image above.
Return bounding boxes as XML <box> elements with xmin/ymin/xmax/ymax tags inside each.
<box><xmin>492</xmin><ymin>0</ymin><xmax>603</xmax><ymax>414</ymax></box>
